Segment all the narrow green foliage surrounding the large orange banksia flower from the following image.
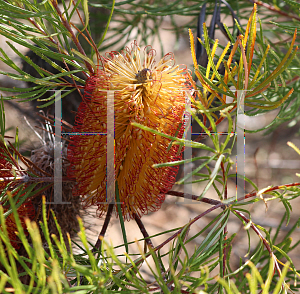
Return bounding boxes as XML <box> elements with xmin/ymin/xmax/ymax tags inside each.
<box><xmin>0</xmin><ymin>0</ymin><xmax>300</xmax><ymax>294</ymax></box>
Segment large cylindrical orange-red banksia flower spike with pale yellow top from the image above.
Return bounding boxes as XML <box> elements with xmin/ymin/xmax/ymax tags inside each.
<box><xmin>68</xmin><ymin>42</ymin><xmax>191</xmax><ymax>220</ymax></box>
